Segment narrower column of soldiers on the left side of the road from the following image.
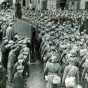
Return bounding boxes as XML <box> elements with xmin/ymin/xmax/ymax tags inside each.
<box><xmin>0</xmin><ymin>9</ymin><xmax>30</xmax><ymax>88</ymax></box>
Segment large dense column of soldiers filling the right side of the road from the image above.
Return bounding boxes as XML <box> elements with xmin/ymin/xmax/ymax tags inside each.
<box><xmin>24</xmin><ymin>10</ymin><xmax>88</xmax><ymax>88</ymax></box>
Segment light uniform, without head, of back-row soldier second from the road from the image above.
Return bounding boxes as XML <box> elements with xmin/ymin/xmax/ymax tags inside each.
<box><xmin>62</xmin><ymin>65</ymin><xmax>79</xmax><ymax>88</ymax></box>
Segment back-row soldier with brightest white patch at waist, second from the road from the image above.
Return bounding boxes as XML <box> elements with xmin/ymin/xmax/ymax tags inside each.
<box><xmin>62</xmin><ymin>57</ymin><xmax>79</xmax><ymax>88</ymax></box>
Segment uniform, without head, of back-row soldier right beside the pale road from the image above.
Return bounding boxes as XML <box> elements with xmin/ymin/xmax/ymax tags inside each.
<box><xmin>44</xmin><ymin>57</ymin><xmax>61</xmax><ymax>88</ymax></box>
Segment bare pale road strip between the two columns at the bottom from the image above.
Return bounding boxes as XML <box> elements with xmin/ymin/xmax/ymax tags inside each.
<box><xmin>27</xmin><ymin>63</ymin><xmax>46</xmax><ymax>88</ymax></box>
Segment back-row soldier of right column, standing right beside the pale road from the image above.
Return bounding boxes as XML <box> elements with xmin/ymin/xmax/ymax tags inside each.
<box><xmin>44</xmin><ymin>56</ymin><xmax>61</xmax><ymax>88</ymax></box>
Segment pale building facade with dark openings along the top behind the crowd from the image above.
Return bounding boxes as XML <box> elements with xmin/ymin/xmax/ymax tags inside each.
<box><xmin>9</xmin><ymin>0</ymin><xmax>88</xmax><ymax>10</ymax></box>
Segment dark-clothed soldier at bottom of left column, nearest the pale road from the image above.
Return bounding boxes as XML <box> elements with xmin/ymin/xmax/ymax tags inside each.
<box><xmin>13</xmin><ymin>58</ymin><xmax>25</xmax><ymax>88</ymax></box>
